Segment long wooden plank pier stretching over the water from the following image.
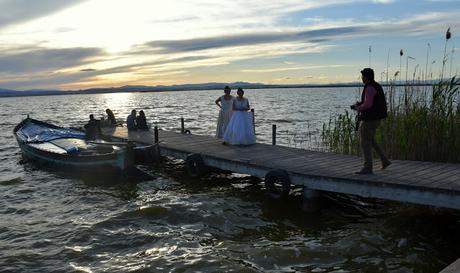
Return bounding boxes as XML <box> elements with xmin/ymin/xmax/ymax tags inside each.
<box><xmin>103</xmin><ymin>127</ymin><xmax>460</xmax><ymax>209</ymax></box>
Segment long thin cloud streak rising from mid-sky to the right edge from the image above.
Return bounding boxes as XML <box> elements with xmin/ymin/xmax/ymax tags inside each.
<box><xmin>141</xmin><ymin>7</ymin><xmax>460</xmax><ymax>54</ymax></box>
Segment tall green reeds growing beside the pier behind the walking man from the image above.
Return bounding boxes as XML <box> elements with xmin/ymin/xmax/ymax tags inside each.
<box><xmin>321</xmin><ymin>29</ymin><xmax>460</xmax><ymax>163</ymax></box>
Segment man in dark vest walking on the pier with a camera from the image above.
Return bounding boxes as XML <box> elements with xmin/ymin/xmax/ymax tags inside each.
<box><xmin>351</xmin><ymin>68</ymin><xmax>391</xmax><ymax>174</ymax></box>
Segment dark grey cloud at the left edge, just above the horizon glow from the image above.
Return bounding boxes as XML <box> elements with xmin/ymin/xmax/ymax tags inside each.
<box><xmin>0</xmin><ymin>48</ymin><xmax>104</xmax><ymax>74</ymax></box>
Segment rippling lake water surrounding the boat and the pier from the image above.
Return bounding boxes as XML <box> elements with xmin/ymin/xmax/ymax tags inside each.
<box><xmin>0</xmin><ymin>88</ymin><xmax>460</xmax><ymax>273</ymax></box>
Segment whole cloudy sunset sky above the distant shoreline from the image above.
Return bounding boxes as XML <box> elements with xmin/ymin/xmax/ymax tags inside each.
<box><xmin>0</xmin><ymin>0</ymin><xmax>460</xmax><ymax>90</ymax></box>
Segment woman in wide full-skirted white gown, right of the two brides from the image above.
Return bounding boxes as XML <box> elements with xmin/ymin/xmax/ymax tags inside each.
<box><xmin>224</xmin><ymin>88</ymin><xmax>256</xmax><ymax>145</ymax></box>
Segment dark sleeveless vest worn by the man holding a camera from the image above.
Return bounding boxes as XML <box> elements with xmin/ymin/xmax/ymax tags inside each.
<box><xmin>360</xmin><ymin>82</ymin><xmax>388</xmax><ymax>120</ymax></box>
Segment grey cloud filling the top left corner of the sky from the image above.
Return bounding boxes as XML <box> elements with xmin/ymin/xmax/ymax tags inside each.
<box><xmin>0</xmin><ymin>0</ymin><xmax>85</xmax><ymax>28</ymax></box>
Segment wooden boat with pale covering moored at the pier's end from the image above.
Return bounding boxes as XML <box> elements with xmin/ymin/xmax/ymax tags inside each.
<box><xmin>13</xmin><ymin>117</ymin><xmax>132</xmax><ymax>171</ymax></box>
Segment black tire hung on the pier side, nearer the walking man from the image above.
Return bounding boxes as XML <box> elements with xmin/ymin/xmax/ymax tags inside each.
<box><xmin>265</xmin><ymin>170</ymin><xmax>291</xmax><ymax>199</ymax></box>
